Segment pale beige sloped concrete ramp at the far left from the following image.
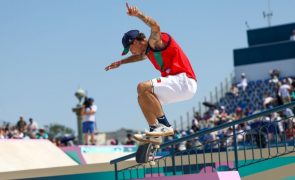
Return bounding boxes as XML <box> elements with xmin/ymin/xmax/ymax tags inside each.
<box><xmin>0</xmin><ymin>140</ymin><xmax>77</xmax><ymax>172</ymax></box>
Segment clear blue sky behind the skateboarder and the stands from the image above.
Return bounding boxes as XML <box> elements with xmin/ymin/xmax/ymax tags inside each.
<box><xmin>0</xmin><ymin>0</ymin><xmax>295</xmax><ymax>132</ymax></box>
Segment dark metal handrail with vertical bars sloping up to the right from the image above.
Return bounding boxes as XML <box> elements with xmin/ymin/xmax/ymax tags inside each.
<box><xmin>110</xmin><ymin>102</ymin><xmax>295</xmax><ymax>180</ymax></box>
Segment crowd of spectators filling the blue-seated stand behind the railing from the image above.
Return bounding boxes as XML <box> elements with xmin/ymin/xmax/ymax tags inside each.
<box><xmin>165</xmin><ymin>69</ymin><xmax>295</xmax><ymax>150</ymax></box>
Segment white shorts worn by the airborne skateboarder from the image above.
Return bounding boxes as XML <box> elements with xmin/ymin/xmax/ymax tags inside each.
<box><xmin>151</xmin><ymin>73</ymin><xmax>197</xmax><ymax>105</ymax></box>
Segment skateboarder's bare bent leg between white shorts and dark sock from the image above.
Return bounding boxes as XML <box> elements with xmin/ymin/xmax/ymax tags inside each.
<box><xmin>137</xmin><ymin>81</ymin><xmax>164</xmax><ymax>125</ymax></box>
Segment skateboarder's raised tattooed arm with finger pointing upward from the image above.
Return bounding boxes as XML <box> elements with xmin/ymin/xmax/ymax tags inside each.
<box><xmin>126</xmin><ymin>3</ymin><xmax>165</xmax><ymax>49</ymax></box>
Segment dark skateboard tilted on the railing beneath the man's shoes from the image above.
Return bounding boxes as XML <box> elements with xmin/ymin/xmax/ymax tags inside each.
<box><xmin>136</xmin><ymin>143</ymin><xmax>160</xmax><ymax>166</ymax></box>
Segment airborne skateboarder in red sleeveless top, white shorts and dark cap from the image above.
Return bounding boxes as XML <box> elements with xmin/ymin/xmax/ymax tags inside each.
<box><xmin>105</xmin><ymin>3</ymin><xmax>197</xmax><ymax>144</ymax></box>
